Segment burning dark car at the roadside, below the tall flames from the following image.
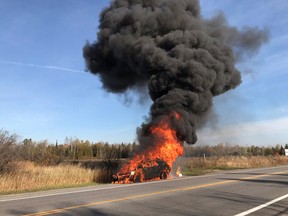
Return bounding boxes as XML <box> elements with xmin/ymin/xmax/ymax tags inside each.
<box><xmin>113</xmin><ymin>159</ymin><xmax>171</xmax><ymax>183</ymax></box>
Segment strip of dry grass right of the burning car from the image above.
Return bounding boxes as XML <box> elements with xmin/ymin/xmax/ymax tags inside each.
<box><xmin>183</xmin><ymin>156</ymin><xmax>288</xmax><ymax>175</ymax></box>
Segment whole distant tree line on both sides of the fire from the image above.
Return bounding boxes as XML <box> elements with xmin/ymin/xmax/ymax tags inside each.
<box><xmin>0</xmin><ymin>129</ymin><xmax>288</xmax><ymax>173</ymax></box>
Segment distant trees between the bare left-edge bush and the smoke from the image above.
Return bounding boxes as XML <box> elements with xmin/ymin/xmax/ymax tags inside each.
<box><xmin>18</xmin><ymin>138</ymin><xmax>137</xmax><ymax>162</ymax></box>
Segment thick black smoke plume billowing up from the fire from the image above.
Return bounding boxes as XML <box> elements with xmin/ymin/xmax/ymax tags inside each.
<box><xmin>83</xmin><ymin>0</ymin><xmax>268</xmax><ymax>144</ymax></box>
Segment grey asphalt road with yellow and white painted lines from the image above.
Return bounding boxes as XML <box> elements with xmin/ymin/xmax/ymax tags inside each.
<box><xmin>0</xmin><ymin>166</ymin><xmax>288</xmax><ymax>216</ymax></box>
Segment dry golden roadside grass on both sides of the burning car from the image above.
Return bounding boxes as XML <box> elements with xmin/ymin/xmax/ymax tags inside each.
<box><xmin>0</xmin><ymin>156</ymin><xmax>288</xmax><ymax>194</ymax></box>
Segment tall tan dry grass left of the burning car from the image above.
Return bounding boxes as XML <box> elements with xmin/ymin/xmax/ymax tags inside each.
<box><xmin>0</xmin><ymin>162</ymin><xmax>94</xmax><ymax>194</ymax></box>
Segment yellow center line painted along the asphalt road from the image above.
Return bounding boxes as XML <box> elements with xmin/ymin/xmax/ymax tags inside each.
<box><xmin>24</xmin><ymin>172</ymin><xmax>287</xmax><ymax>216</ymax></box>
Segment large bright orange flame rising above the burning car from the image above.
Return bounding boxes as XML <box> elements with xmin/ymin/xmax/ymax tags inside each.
<box><xmin>119</xmin><ymin>113</ymin><xmax>184</xmax><ymax>183</ymax></box>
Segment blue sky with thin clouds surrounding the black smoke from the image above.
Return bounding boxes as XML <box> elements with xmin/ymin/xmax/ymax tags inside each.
<box><xmin>0</xmin><ymin>0</ymin><xmax>288</xmax><ymax>145</ymax></box>
